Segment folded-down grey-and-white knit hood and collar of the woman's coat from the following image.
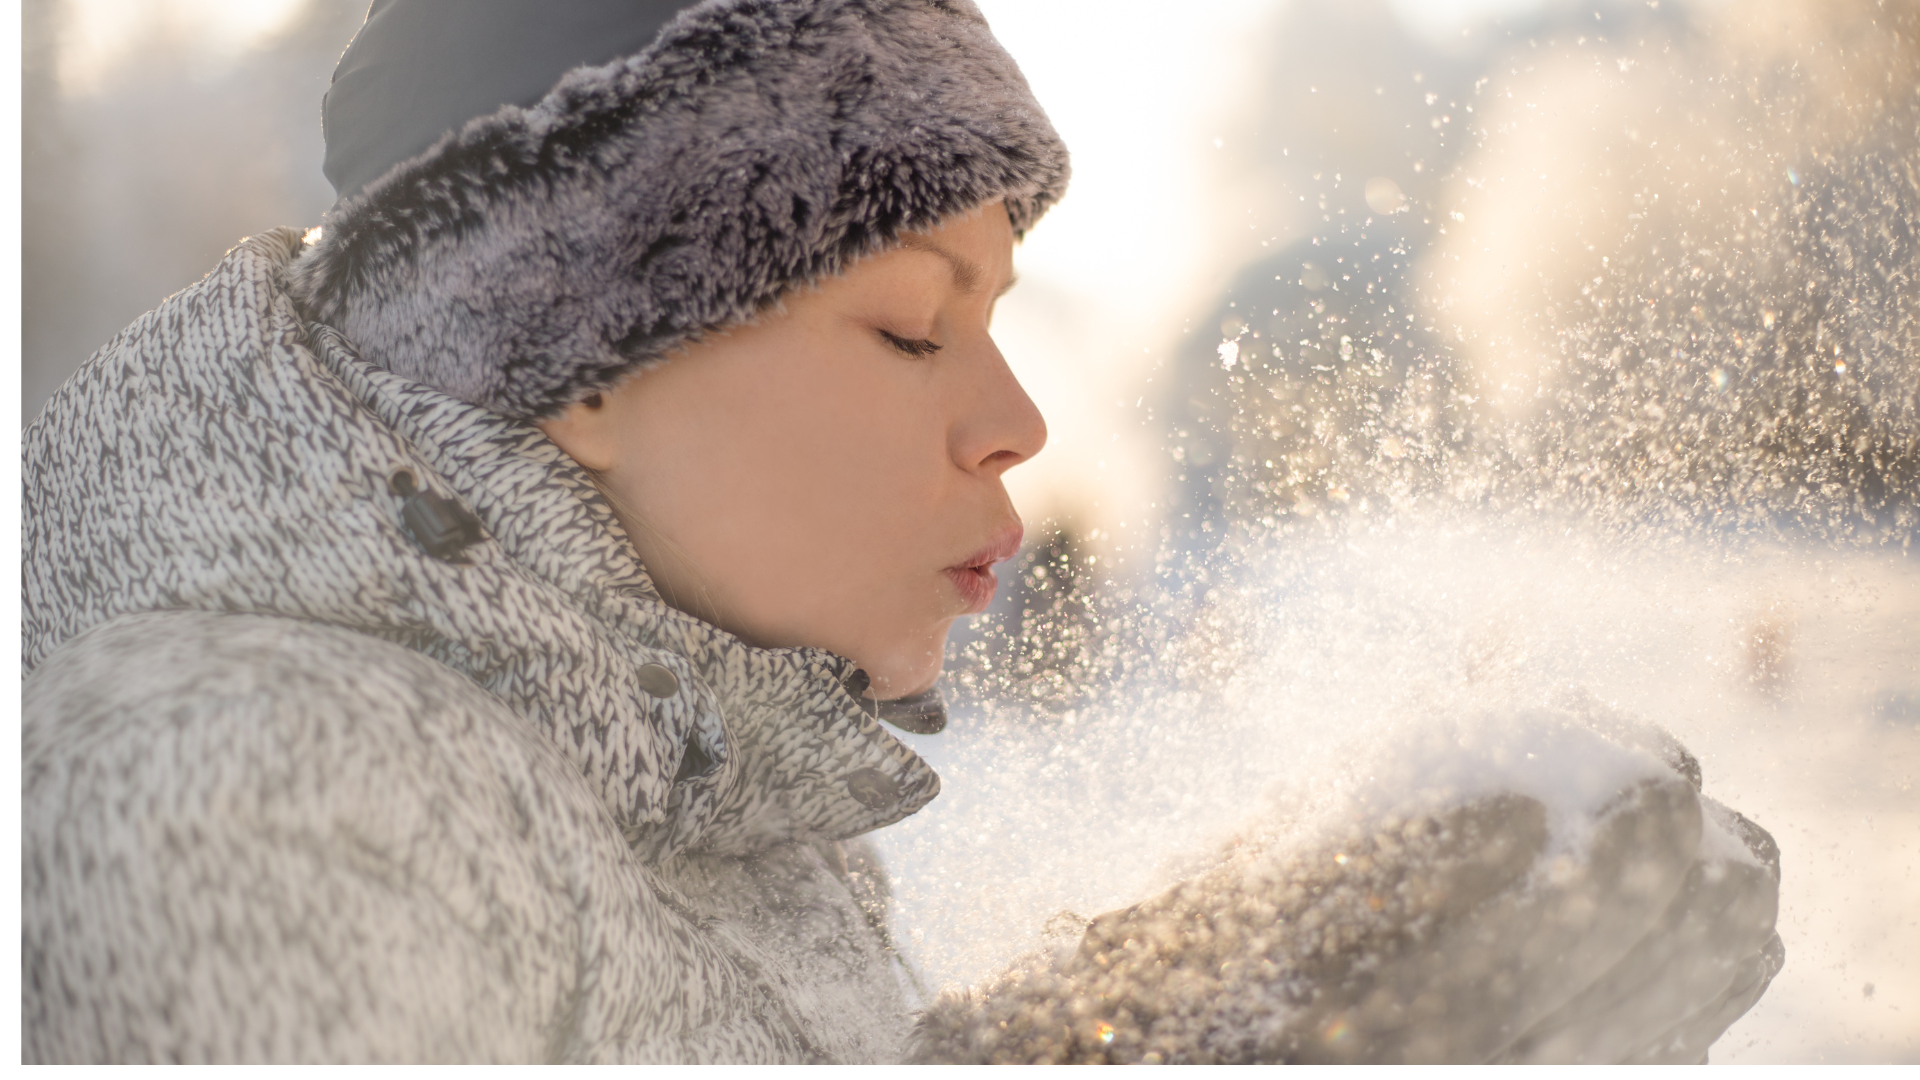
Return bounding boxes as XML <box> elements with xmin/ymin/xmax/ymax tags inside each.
<box><xmin>21</xmin><ymin>229</ymin><xmax>939</xmax><ymax>861</ymax></box>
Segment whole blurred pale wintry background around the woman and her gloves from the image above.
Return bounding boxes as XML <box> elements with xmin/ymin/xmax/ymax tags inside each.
<box><xmin>23</xmin><ymin>0</ymin><xmax>1920</xmax><ymax>1063</ymax></box>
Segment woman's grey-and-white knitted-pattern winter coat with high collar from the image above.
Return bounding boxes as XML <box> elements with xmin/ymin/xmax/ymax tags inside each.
<box><xmin>21</xmin><ymin>229</ymin><xmax>939</xmax><ymax>1061</ymax></box>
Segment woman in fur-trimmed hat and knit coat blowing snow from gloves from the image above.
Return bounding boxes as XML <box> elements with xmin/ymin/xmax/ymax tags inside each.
<box><xmin>23</xmin><ymin>0</ymin><xmax>1778</xmax><ymax>1061</ymax></box>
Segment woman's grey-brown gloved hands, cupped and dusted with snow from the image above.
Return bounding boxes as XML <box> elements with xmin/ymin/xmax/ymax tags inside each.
<box><xmin>916</xmin><ymin>707</ymin><xmax>1782</xmax><ymax>1063</ymax></box>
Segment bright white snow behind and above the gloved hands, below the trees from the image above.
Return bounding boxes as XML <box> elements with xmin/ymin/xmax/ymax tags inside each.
<box><xmin>877</xmin><ymin>521</ymin><xmax>1920</xmax><ymax>1061</ymax></box>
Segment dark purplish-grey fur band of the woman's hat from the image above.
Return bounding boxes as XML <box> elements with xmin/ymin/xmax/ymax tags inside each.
<box><xmin>290</xmin><ymin>0</ymin><xmax>1068</xmax><ymax>419</ymax></box>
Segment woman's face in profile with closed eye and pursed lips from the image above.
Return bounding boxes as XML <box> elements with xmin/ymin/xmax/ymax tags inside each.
<box><xmin>541</xmin><ymin>204</ymin><xmax>1046</xmax><ymax>698</ymax></box>
